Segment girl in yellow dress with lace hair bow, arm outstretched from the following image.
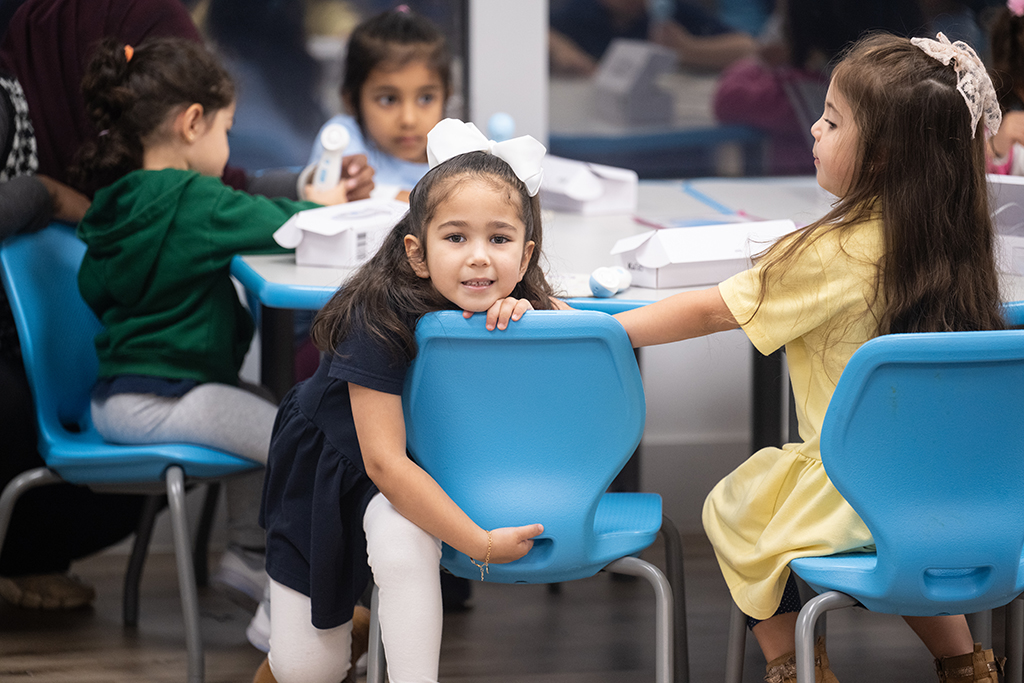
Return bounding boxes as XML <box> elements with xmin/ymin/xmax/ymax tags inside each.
<box><xmin>616</xmin><ymin>34</ymin><xmax>1005</xmax><ymax>683</ymax></box>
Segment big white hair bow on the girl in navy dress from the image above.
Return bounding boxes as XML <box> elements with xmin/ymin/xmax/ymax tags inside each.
<box><xmin>427</xmin><ymin>119</ymin><xmax>548</xmax><ymax>197</ymax></box>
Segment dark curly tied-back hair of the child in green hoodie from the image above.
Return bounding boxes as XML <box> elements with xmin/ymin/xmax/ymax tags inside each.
<box><xmin>71</xmin><ymin>38</ymin><xmax>234</xmax><ymax>193</ymax></box>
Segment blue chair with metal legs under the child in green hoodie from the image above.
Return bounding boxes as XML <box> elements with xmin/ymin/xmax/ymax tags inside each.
<box><xmin>0</xmin><ymin>225</ymin><xmax>259</xmax><ymax>683</ymax></box>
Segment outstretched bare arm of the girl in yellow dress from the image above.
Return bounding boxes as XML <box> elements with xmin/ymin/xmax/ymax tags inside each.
<box><xmin>615</xmin><ymin>287</ymin><xmax>739</xmax><ymax>347</ymax></box>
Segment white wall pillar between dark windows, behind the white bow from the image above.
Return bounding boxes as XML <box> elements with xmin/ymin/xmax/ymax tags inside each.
<box><xmin>467</xmin><ymin>0</ymin><xmax>548</xmax><ymax>144</ymax></box>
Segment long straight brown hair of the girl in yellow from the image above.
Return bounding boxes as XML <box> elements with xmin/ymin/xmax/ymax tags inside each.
<box><xmin>755</xmin><ymin>34</ymin><xmax>1006</xmax><ymax>335</ymax></box>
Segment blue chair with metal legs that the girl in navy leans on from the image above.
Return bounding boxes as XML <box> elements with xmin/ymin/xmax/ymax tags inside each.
<box><xmin>367</xmin><ymin>311</ymin><xmax>687</xmax><ymax>683</ymax></box>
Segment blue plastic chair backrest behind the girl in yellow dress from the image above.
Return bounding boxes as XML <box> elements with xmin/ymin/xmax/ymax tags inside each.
<box><xmin>821</xmin><ymin>331</ymin><xmax>1024</xmax><ymax>614</ymax></box>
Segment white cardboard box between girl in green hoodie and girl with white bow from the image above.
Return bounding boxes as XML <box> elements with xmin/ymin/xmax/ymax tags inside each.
<box><xmin>273</xmin><ymin>199</ymin><xmax>409</xmax><ymax>268</ymax></box>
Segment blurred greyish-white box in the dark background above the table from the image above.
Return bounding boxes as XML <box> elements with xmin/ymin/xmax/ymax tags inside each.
<box><xmin>594</xmin><ymin>38</ymin><xmax>678</xmax><ymax>126</ymax></box>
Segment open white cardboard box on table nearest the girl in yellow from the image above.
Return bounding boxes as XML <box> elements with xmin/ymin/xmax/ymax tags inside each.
<box><xmin>611</xmin><ymin>220</ymin><xmax>797</xmax><ymax>288</ymax></box>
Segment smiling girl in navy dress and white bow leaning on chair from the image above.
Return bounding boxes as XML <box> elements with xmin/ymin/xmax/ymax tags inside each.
<box><xmin>261</xmin><ymin>119</ymin><xmax>557</xmax><ymax>683</ymax></box>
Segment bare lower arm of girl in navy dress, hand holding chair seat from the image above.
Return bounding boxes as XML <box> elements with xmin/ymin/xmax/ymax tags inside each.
<box><xmin>348</xmin><ymin>382</ymin><xmax>544</xmax><ymax>564</ymax></box>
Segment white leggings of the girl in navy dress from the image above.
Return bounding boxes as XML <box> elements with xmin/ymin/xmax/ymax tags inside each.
<box><xmin>269</xmin><ymin>494</ymin><xmax>442</xmax><ymax>683</ymax></box>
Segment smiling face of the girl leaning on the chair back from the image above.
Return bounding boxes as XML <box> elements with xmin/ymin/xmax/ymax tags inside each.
<box><xmin>406</xmin><ymin>178</ymin><xmax>534</xmax><ymax>312</ymax></box>
